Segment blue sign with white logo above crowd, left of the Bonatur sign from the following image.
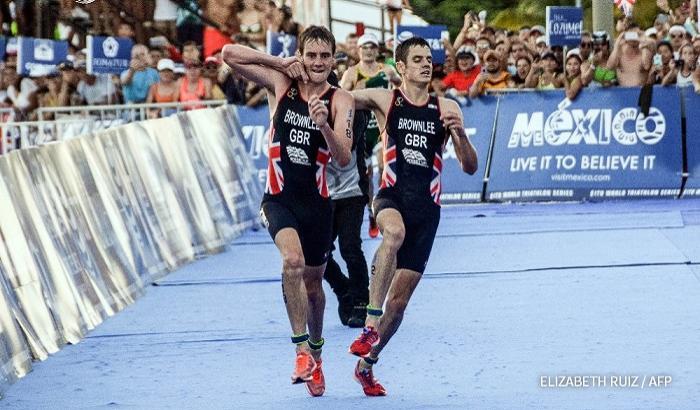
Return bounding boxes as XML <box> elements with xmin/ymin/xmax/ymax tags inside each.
<box><xmin>17</xmin><ymin>37</ymin><xmax>68</xmax><ymax>77</ymax></box>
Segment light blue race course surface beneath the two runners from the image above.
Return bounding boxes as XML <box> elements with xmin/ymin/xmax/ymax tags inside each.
<box><xmin>0</xmin><ymin>200</ymin><xmax>700</xmax><ymax>409</ymax></box>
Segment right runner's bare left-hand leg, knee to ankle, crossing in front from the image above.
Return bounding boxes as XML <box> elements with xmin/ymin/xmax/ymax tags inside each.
<box><xmin>365</xmin><ymin>208</ymin><xmax>406</xmax><ymax>329</ymax></box>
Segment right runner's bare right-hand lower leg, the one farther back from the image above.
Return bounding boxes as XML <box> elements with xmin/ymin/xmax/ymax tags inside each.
<box><xmin>370</xmin><ymin>269</ymin><xmax>422</xmax><ymax>359</ymax></box>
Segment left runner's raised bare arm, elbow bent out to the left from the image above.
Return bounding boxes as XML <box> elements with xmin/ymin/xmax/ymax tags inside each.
<box><xmin>222</xmin><ymin>44</ymin><xmax>296</xmax><ymax>95</ymax></box>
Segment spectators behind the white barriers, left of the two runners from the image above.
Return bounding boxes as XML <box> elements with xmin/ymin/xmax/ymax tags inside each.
<box><xmin>0</xmin><ymin>0</ymin><xmax>303</xmax><ymax>120</ymax></box>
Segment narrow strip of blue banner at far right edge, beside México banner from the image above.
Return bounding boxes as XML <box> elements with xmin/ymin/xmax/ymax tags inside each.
<box><xmin>682</xmin><ymin>87</ymin><xmax>700</xmax><ymax>198</ymax></box>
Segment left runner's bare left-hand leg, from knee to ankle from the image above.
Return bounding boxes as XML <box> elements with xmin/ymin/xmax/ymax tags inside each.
<box><xmin>275</xmin><ymin>228</ymin><xmax>308</xmax><ymax>342</ymax></box>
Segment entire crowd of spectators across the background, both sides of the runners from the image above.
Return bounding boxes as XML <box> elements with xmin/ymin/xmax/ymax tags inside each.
<box><xmin>0</xmin><ymin>0</ymin><xmax>700</xmax><ymax>119</ymax></box>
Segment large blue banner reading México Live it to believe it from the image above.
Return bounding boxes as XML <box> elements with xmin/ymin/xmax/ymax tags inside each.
<box><xmin>486</xmin><ymin>87</ymin><xmax>683</xmax><ymax>201</ymax></box>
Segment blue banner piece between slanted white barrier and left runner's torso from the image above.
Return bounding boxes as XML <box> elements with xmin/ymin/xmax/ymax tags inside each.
<box><xmin>236</xmin><ymin>105</ymin><xmax>270</xmax><ymax>186</ymax></box>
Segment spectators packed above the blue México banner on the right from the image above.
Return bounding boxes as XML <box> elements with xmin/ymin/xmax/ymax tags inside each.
<box><xmin>422</xmin><ymin>0</ymin><xmax>700</xmax><ymax>104</ymax></box>
